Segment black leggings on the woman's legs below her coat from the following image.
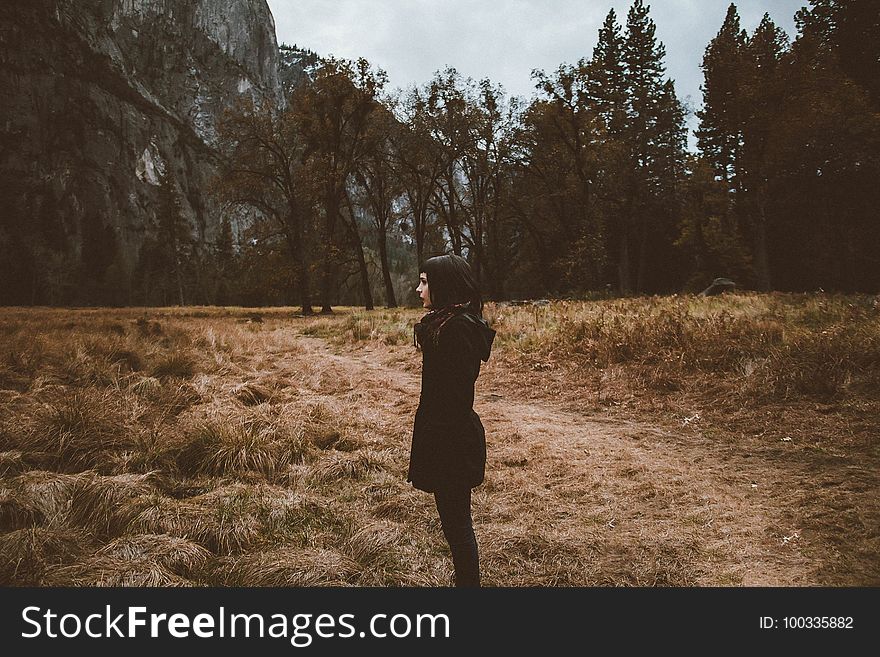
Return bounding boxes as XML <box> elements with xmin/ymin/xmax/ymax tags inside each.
<box><xmin>434</xmin><ymin>488</ymin><xmax>480</xmax><ymax>586</ymax></box>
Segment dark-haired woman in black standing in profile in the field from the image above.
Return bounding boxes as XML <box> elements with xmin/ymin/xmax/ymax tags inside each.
<box><xmin>407</xmin><ymin>255</ymin><xmax>495</xmax><ymax>586</ymax></box>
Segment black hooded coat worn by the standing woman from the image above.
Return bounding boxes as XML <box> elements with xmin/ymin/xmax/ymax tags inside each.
<box><xmin>407</xmin><ymin>312</ymin><xmax>495</xmax><ymax>492</ymax></box>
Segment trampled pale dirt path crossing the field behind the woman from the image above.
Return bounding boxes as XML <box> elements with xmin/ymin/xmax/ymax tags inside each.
<box><xmin>301</xmin><ymin>336</ymin><xmax>821</xmax><ymax>586</ymax></box>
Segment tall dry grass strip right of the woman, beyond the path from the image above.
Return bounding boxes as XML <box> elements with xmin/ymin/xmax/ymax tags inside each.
<box><xmin>486</xmin><ymin>294</ymin><xmax>880</xmax><ymax>399</ymax></box>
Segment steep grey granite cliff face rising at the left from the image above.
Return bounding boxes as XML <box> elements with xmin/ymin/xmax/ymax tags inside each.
<box><xmin>0</xmin><ymin>0</ymin><xmax>282</xmax><ymax>304</ymax></box>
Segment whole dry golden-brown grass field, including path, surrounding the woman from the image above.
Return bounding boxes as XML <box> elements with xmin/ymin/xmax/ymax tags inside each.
<box><xmin>0</xmin><ymin>294</ymin><xmax>880</xmax><ymax>587</ymax></box>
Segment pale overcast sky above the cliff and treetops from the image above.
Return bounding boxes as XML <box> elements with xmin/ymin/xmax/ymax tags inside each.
<box><xmin>268</xmin><ymin>0</ymin><xmax>808</xmax><ymax>142</ymax></box>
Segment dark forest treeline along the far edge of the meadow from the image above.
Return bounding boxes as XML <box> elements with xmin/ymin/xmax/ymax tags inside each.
<box><xmin>3</xmin><ymin>0</ymin><xmax>880</xmax><ymax>313</ymax></box>
